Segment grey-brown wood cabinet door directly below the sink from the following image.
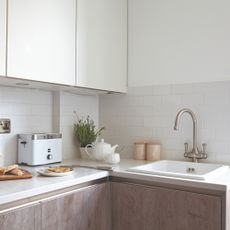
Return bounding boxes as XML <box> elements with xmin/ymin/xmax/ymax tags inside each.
<box><xmin>111</xmin><ymin>182</ymin><xmax>222</xmax><ymax>230</ymax></box>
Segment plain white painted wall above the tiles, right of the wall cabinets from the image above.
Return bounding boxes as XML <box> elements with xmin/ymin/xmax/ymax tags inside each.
<box><xmin>128</xmin><ymin>0</ymin><xmax>230</xmax><ymax>87</ymax></box>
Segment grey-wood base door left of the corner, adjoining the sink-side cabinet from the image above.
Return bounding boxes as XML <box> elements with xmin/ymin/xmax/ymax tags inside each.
<box><xmin>41</xmin><ymin>183</ymin><xmax>110</xmax><ymax>230</ymax></box>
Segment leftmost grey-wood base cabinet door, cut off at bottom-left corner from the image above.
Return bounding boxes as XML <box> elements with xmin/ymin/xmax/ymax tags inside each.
<box><xmin>0</xmin><ymin>204</ymin><xmax>41</xmax><ymax>230</ymax></box>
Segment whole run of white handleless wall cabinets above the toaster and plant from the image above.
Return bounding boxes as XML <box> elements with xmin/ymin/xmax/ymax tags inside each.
<box><xmin>4</xmin><ymin>0</ymin><xmax>127</xmax><ymax>92</ymax></box>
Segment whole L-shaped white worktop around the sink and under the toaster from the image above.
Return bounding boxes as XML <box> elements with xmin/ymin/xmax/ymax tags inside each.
<box><xmin>0</xmin><ymin>159</ymin><xmax>230</xmax><ymax>205</ymax></box>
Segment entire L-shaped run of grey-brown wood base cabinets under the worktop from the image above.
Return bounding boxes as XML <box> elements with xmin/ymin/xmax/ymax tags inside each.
<box><xmin>0</xmin><ymin>182</ymin><xmax>225</xmax><ymax>230</ymax></box>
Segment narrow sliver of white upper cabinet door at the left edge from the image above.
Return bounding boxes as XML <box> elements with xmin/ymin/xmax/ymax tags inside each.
<box><xmin>0</xmin><ymin>0</ymin><xmax>6</xmax><ymax>76</ymax></box>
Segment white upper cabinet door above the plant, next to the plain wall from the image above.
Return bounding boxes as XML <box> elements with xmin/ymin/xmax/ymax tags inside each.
<box><xmin>76</xmin><ymin>0</ymin><xmax>127</xmax><ymax>92</ymax></box>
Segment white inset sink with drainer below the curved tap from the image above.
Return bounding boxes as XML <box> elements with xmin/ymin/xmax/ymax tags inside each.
<box><xmin>127</xmin><ymin>160</ymin><xmax>229</xmax><ymax>180</ymax></box>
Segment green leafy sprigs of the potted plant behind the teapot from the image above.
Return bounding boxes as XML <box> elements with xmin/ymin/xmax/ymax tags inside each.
<box><xmin>74</xmin><ymin>112</ymin><xmax>105</xmax><ymax>147</ymax></box>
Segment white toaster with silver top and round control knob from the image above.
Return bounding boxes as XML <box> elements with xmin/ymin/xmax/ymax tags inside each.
<box><xmin>18</xmin><ymin>133</ymin><xmax>62</xmax><ymax>166</ymax></box>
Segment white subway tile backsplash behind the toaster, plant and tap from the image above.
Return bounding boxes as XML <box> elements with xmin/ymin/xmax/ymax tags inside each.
<box><xmin>0</xmin><ymin>82</ymin><xmax>230</xmax><ymax>164</ymax></box>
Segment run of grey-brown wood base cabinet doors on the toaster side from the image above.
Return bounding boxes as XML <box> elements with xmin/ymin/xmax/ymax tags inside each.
<box><xmin>0</xmin><ymin>183</ymin><xmax>111</xmax><ymax>230</ymax></box>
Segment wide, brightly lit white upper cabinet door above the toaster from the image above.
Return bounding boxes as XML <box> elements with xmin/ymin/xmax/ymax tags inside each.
<box><xmin>7</xmin><ymin>0</ymin><xmax>76</xmax><ymax>85</ymax></box>
